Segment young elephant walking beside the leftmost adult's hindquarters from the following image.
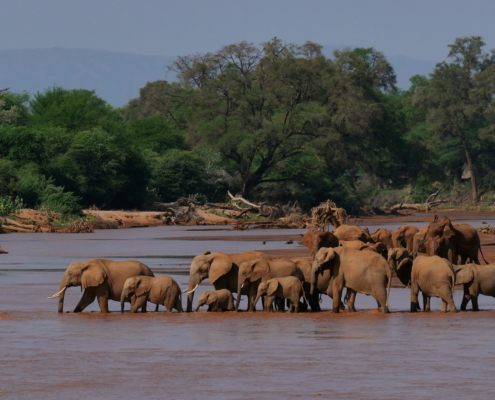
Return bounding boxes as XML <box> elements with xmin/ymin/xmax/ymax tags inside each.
<box><xmin>120</xmin><ymin>276</ymin><xmax>182</xmax><ymax>313</ymax></box>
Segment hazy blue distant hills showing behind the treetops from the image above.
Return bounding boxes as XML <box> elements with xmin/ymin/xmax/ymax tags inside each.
<box><xmin>0</xmin><ymin>46</ymin><xmax>435</xmax><ymax>107</ymax></box>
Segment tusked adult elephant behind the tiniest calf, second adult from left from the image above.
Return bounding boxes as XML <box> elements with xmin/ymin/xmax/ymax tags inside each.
<box><xmin>183</xmin><ymin>251</ymin><xmax>271</xmax><ymax>312</ymax></box>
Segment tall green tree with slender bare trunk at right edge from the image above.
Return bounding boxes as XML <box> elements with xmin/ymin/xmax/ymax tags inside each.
<box><xmin>415</xmin><ymin>36</ymin><xmax>495</xmax><ymax>201</ymax></box>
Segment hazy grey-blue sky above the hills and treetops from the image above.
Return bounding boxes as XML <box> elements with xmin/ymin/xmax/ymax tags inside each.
<box><xmin>0</xmin><ymin>0</ymin><xmax>495</xmax><ymax>60</ymax></box>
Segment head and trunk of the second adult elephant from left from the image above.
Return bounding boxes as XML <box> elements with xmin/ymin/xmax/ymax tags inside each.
<box><xmin>184</xmin><ymin>251</ymin><xmax>233</xmax><ymax>312</ymax></box>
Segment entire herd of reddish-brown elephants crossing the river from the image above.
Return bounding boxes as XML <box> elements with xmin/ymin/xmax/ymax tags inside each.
<box><xmin>50</xmin><ymin>216</ymin><xmax>495</xmax><ymax>313</ymax></box>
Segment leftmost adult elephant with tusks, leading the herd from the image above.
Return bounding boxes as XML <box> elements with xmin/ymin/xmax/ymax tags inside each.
<box><xmin>49</xmin><ymin>258</ymin><xmax>154</xmax><ymax>313</ymax></box>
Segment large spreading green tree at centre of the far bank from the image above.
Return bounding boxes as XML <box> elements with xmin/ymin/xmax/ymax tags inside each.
<box><xmin>172</xmin><ymin>38</ymin><xmax>395</xmax><ymax>196</ymax></box>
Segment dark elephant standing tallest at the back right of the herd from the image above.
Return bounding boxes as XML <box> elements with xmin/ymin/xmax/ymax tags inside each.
<box><xmin>425</xmin><ymin>215</ymin><xmax>488</xmax><ymax>264</ymax></box>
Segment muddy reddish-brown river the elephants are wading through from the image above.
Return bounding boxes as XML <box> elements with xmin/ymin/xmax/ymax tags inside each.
<box><xmin>0</xmin><ymin>216</ymin><xmax>495</xmax><ymax>399</ymax></box>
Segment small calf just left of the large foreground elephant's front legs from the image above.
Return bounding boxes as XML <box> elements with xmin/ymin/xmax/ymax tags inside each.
<box><xmin>254</xmin><ymin>276</ymin><xmax>308</xmax><ymax>313</ymax></box>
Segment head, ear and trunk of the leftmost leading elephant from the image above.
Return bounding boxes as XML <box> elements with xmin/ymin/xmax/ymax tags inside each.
<box><xmin>49</xmin><ymin>258</ymin><xmax>107</xmax><ymax>313</ymax></box>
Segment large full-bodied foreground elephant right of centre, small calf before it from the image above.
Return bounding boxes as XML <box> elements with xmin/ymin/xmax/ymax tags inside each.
<box><xmin>311</xmin><ymin>247</ymin><xmax>392</xmax><ymax>313</ymax></box>
